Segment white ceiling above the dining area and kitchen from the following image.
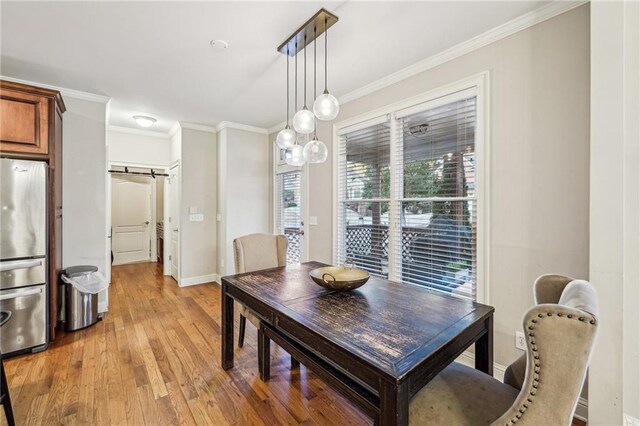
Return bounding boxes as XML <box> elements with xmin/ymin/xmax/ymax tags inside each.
<box><xmin>0</xmin><ymin>1</ymin><xmax>546</xmax><ymax>132</ymax></box>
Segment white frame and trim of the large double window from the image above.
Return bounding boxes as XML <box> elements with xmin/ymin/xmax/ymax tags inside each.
<box><xmin>332</xmin><ymin>71</ymin><xmax>490</xmax><ymax>303</ymax></box>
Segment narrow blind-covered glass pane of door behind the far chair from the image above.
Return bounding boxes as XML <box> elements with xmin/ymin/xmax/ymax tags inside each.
<box><xmin>275</xmin><ymin>171</ymin><xmax>302</xmax><ymax>264</ymax></box>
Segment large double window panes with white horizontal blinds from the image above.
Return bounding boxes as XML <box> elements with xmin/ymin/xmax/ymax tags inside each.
<box><xmin>337</xmin><ymin>96</ymin><xmax>477</xmax><ymax>299</ymax></box>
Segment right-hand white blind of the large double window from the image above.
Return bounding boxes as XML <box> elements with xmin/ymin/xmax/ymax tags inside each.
<box><xmin>392</xmin><ymin>97</ymin><xmax>477</xmax><ymax>299</ymax></box>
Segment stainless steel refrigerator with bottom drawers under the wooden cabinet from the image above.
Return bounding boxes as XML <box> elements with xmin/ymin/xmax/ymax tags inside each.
<box><xmin>0</xmin><ymin>158</ymin><xmax>48</xmax><ymax>355</ymax></box>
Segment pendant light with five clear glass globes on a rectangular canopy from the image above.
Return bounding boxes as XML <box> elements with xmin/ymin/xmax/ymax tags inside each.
<box><xmin>276</xmin><ymin>9</ymin><xmax>339</xmax><ymax>166</ymax></box>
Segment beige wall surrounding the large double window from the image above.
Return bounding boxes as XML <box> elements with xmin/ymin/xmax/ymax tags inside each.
<box><xmin>284</xmin><ymin>5</ymin><xmax>589</xmax><ymax>372</ymax></box>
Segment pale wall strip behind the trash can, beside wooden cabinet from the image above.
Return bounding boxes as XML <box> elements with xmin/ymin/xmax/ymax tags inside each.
<box><xmin>62</xmin><ymin>97</ymin><xmax>111</xmax><ymax>311</ymax></box>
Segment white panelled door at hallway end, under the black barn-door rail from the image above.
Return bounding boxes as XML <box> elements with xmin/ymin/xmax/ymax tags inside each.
<box><xmin>111</xmin><ymin>177</ymin><xmax>152</xmax><ymax>265</ymax></box>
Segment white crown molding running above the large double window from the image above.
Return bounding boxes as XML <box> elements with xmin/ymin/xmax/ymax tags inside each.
<box><xmin>338</xmin><ymin>0</ymin><xmax>587</xmax><ymax>105</ymax></box>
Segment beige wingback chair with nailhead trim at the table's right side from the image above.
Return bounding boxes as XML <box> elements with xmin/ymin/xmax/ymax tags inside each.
<box><xmin>409</xmin><ymin>275</ymin><xmax>598</xmax><ymax>426</ymax></box>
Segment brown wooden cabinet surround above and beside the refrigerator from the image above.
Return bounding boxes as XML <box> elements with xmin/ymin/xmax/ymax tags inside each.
<box><xmin>0</xmin><ymin>80</ymin><xmax>66</xmax><ymax>340</ymax></box>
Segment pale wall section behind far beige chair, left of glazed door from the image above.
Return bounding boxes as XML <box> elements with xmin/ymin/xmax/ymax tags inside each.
<box><xmin>218</xmin><ymin>128</ymin><xmax>272</xmax><ymax>275</ymax></box>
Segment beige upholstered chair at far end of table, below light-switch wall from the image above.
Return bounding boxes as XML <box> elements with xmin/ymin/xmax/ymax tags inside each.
<box><xmin>233</xmin><ymin>234</ymin><xmax>288</xmax><ymax>347</ymax></box>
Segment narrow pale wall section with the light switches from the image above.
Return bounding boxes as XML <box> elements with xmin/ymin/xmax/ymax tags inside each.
<box><xmin>180</xmin><ymin>128</ymin><xmax>217</xmax><ymax>285</ymax></box>
